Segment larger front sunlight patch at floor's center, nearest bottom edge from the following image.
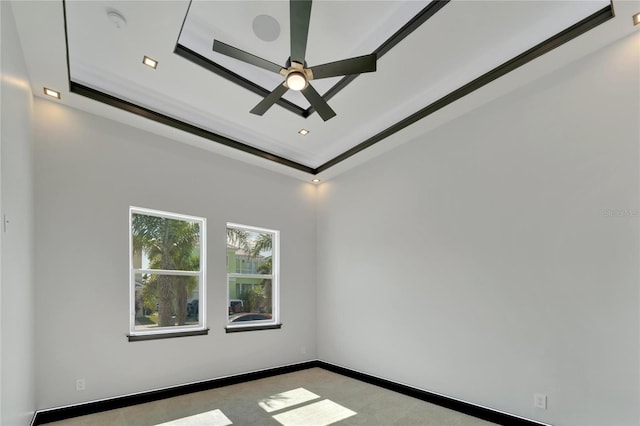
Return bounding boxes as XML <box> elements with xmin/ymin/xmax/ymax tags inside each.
<box><xmin>273</xmin><ymin>399</ymin><xmax>357</xmax><ymax>426</ymax></box>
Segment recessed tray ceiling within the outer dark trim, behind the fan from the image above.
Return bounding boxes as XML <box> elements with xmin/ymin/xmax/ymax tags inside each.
<box><xmin>14</xmin><ymin>0</ymin><xmax>640</xmax><ymax>180</ymax></box>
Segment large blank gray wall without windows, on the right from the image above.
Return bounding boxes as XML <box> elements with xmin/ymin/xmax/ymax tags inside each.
<box><xmin>317</xmin><ymin>33</ymin><xmax>640</xmax><ymax>426</ymax></box>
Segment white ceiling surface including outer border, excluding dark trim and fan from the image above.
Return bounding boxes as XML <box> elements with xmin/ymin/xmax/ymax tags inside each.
<box><xmin>6</xmin><ymin>0</ymin><xmax>640</xmax><ymax>179</ymax></box>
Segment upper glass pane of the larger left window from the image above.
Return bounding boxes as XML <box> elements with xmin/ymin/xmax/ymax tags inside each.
<box><xmin>131</xmin><ymin>213</ymin><xmax>200</xmax><ymax>271</ymax></box>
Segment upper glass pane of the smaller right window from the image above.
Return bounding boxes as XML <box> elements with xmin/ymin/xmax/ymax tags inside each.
<box><xmin>227</xmin><ymin>228</ymin><xmax>273</xmax><ymax>275</ymax></box>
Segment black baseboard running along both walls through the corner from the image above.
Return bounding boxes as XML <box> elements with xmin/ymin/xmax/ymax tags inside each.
<box><xmin>31</xmin><ymin>360</ymin><xmax>544</xmax><ymax>426</ymax></box>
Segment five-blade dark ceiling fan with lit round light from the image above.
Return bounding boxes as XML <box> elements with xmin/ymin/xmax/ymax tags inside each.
<box><xmin>213</xmin><ymin>0</ymin><xmax>377</xmax><ymax>121</ymax></box>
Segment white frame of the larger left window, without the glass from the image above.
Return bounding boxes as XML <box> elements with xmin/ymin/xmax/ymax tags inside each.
<box><xmin>129</xmin><ymin>206</ymin><xmax>207</xmax><ymax>340</ymax></box>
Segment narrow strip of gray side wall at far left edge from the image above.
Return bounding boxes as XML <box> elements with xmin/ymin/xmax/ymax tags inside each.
<box><xmin>0</xmin><ymin>1</ymin><xmax>35</xmax><ymax>425</ymax></box>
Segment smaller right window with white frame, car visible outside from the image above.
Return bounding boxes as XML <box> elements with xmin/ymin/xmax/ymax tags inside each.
<box><xmin>227</xmin><ymin>223</ymin><xmax>280</xmax><ymax>332</ymax></box>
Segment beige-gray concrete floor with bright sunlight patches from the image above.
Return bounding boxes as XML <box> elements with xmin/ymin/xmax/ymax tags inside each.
<box><xmin>50</xmin><ymin>368</ymin><xmax>493</xmax><ymax>426</ymax></box>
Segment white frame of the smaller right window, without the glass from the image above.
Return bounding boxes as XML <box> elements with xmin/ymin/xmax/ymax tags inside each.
<box><xmin>225</xmin><ymin>222</ymin><xmax>281</xmax><ymax>332</ymax></box>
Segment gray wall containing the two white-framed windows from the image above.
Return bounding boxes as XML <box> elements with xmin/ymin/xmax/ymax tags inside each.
<box><xmin>35</xmin><ymin>99</ymin><xmax>317</xmax><ymax>408</ymax></box>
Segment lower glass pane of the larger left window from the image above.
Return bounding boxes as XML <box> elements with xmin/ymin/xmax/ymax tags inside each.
<box><xmin>134</xmin><ymin>274</ymin><xmax>200</xmax><ymax>331</ymax></box>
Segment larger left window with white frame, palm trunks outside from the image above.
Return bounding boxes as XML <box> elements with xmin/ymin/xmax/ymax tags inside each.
<box><xmin>129</xmin><ymin>207</ymin><xmax>207</xmax><ymax>340</ymax></box>
